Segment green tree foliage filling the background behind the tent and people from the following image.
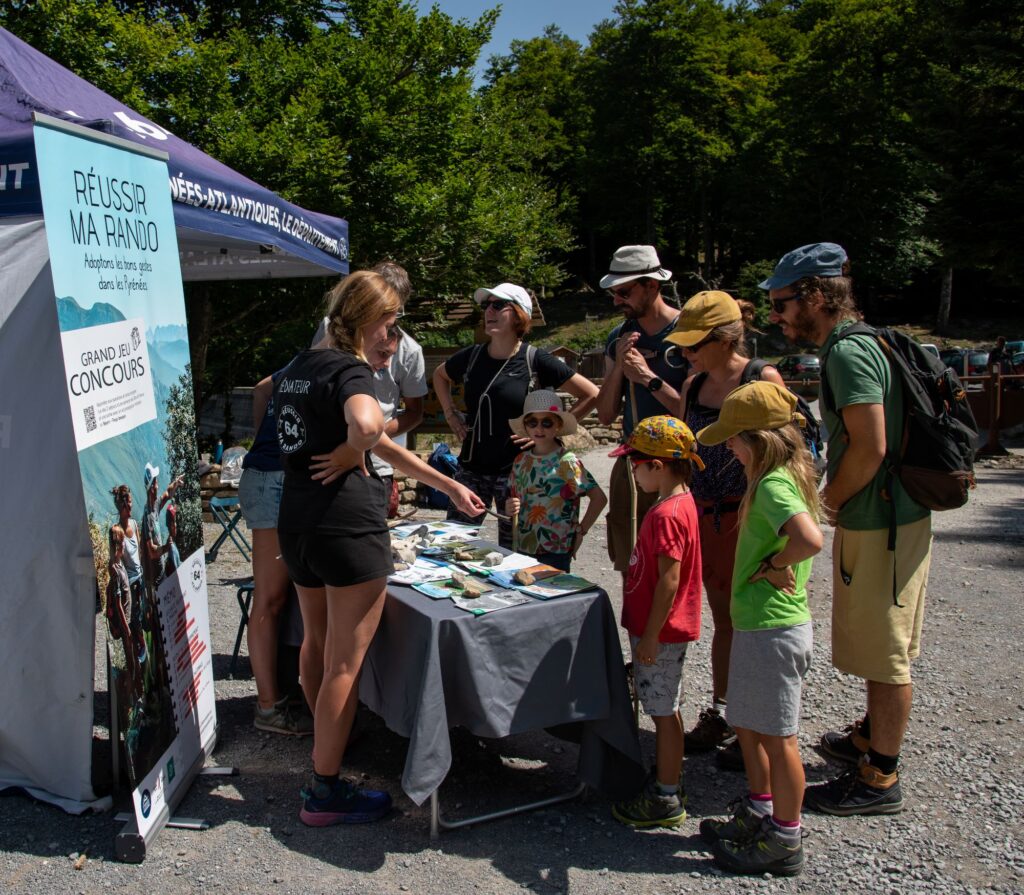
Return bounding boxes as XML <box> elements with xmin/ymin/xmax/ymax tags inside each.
<box><xmin>0</xmin><ymin>0</ymin><xmax>1024</xmax><ymax>403</ymax></box>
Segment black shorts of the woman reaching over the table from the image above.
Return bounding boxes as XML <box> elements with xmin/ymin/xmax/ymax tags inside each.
<box><xmin>278</xmin><ymin>530</ymin><xmax>394</xmax><ymax>588</ymax></box>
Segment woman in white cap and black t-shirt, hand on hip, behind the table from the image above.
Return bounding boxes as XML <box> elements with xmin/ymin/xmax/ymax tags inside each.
<box><xmin>433</xmin><ymin>283</ymin><xmax>597</xmax><ymax>547</ymax></box>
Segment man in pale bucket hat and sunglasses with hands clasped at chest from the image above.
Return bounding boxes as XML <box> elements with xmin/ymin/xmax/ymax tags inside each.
<box><xmin>597</xmin><ymin>246</ymin><xmax>688</xmax><ymax>578</ymax></box>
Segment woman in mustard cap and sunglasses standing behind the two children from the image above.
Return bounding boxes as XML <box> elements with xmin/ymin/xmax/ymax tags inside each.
<box><xmin>667</xmin><ymin>291</ymin><xmax>783</xmax><ymax>770</ymax></box>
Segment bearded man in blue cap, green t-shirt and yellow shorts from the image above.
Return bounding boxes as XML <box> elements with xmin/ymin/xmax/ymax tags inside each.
<box><xmin>761</xmin><ymin>243</ymin><xmax>932</xmax><ymax>816</ymax></box>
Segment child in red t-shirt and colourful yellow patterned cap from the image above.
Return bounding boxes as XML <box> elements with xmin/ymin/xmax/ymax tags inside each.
<box><xmin>611</xmin><ymin>416</ymin><xmax>703</xmax><ymax>826</ymax></box>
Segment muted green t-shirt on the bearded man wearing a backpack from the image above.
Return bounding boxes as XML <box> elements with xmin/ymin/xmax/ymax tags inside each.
<box><xmin>818</xmin><ymin>319</ymin><xmax>928</xmax><ymax>531</ymax></box>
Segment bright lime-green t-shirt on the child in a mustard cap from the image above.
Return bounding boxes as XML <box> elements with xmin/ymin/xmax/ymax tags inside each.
<box><xmin>730</xmin><ymin>467</ymin><xmax>811</xmax><ymax>631</ymax></box>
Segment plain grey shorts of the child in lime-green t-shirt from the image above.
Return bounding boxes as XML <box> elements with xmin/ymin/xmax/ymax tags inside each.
<box><xmin>725</xmin><ymin>622</ymin><xmax>814</xmax><ymax>736</ymax></box>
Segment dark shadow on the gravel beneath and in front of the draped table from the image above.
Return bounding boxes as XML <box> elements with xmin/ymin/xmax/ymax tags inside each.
<box><xmin>192</xmin><ymin>697</ymin><xmax>724</xmax><ymax>876</ymax></box>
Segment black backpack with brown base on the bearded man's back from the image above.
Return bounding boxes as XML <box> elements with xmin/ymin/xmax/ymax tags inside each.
<box><xmin>821</xmin><ymin>323</ymin><xmax>978</xmax><ymax>512</ymax></box>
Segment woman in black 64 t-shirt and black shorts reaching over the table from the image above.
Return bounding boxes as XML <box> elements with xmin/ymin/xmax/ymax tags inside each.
<box><xmin>274</xmin><ymin>271</ymin><xmax>479</xmax><ymax>826</ymax></box>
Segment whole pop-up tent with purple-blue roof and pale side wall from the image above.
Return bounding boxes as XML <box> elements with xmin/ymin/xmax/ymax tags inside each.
<box><xmin>0</xmin><ymin>29</ymin><xmax>348</xmax><ymax>811</ymax></box>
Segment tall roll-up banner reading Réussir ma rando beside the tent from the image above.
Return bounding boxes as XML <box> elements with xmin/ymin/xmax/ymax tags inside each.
<box><xmin>35</xmin><ymin>120</ymin><xmax>216</xmax><ymax>836</ymax></box>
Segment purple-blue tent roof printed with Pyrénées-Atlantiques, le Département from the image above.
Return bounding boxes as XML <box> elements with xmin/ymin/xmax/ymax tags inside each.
<box><xmin>0</xmin><ymin>28</ymin><xmax>348</xmax><ymax>280</ymax></box>
